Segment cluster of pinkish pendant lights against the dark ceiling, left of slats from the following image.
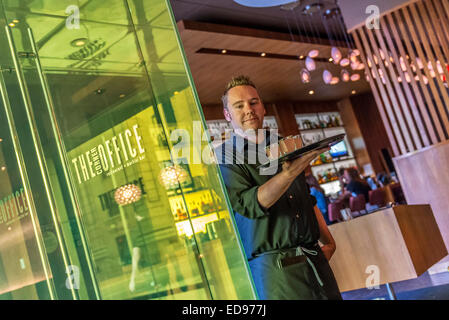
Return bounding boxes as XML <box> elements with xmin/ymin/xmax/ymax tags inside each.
<box><xmin>301</xmin><ymin>47</ymin><xmax>365</xmax><ymax>85</ymax></box>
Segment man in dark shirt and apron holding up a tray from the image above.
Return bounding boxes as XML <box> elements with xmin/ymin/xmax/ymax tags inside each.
<box><xmin>215</xmin><ymin>76</ymin><xmax>341</xmax><ymax>300</ymax></box>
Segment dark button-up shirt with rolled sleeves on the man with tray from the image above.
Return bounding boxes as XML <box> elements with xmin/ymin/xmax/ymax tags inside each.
<box><xmin>215</xmin><ymin>135</ymin><xmax>320</xmax><ymax>259</ymax></box>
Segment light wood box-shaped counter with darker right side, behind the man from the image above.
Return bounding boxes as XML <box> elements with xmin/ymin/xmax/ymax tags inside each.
<box><xmin>329</xmin><ymin>205</ymin><xmax>448</xmax><ymax>292</ymax></box>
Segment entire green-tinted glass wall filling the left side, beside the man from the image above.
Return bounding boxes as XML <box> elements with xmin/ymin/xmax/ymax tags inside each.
<box><xmin>0</xmin><ymin>0</ymin><xmax>256</xmax><ymax>299</ymax></box>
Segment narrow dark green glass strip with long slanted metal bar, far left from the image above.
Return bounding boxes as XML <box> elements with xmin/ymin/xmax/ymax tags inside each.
<box><xmin>0</xmin><ymin>11</ymin><xmax>93</xmax><ymax>299</ymax></box>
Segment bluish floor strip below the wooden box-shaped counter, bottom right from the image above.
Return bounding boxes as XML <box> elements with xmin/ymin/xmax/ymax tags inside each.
<box><xmin>342</xmin><ymin>271</ymin><xmax>449</xmax><ymax>300</ymax></box>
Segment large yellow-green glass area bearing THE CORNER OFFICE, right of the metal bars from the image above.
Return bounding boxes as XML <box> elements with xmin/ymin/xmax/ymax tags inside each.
<box><xmin>2</xmin><ymin>0</ymin><xmax>254</xmax><ymax>299</ymax></box>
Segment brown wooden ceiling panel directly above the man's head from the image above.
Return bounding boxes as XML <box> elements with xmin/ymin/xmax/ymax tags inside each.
<box><xmin>178</xmin><ymin>21</ymin><xmax>370</xmax><ymax>105</ymax></box>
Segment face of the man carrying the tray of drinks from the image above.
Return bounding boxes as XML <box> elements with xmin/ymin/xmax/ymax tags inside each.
<box><xmin>223</xmin><ymin>86</ymin><xmax>266</xmax><ymax>131</ymax></box>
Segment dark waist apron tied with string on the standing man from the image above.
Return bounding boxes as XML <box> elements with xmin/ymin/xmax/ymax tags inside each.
<box><xmin>249</xmin><ymin>244</ymin><xmax>342</xmax><ymax>300</ymax></box>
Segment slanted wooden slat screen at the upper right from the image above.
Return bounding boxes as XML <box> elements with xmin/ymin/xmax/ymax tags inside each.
<box><xmin>352</xmin><ymin>0</ymin><xmax>449</xmax><ymax>156</ymax></box>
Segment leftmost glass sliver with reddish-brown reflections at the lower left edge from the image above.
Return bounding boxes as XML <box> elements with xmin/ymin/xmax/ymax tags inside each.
<box><xmin>0</xmin><ymin>69</ymin><xmax>53</xmax><ymax>300</ymax></box>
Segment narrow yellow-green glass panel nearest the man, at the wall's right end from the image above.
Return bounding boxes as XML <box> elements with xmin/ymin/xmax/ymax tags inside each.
<box><xmin>131</xmin><ymin>0</ymin><xmax>255</xmax><ymax>299</ymax></box>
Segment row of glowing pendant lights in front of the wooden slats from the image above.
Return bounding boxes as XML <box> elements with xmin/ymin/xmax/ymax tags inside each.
<box><xmin>366</xmin><ymin>49</ymin><xmax>449</xmax><ymax>87</ymax></box>
